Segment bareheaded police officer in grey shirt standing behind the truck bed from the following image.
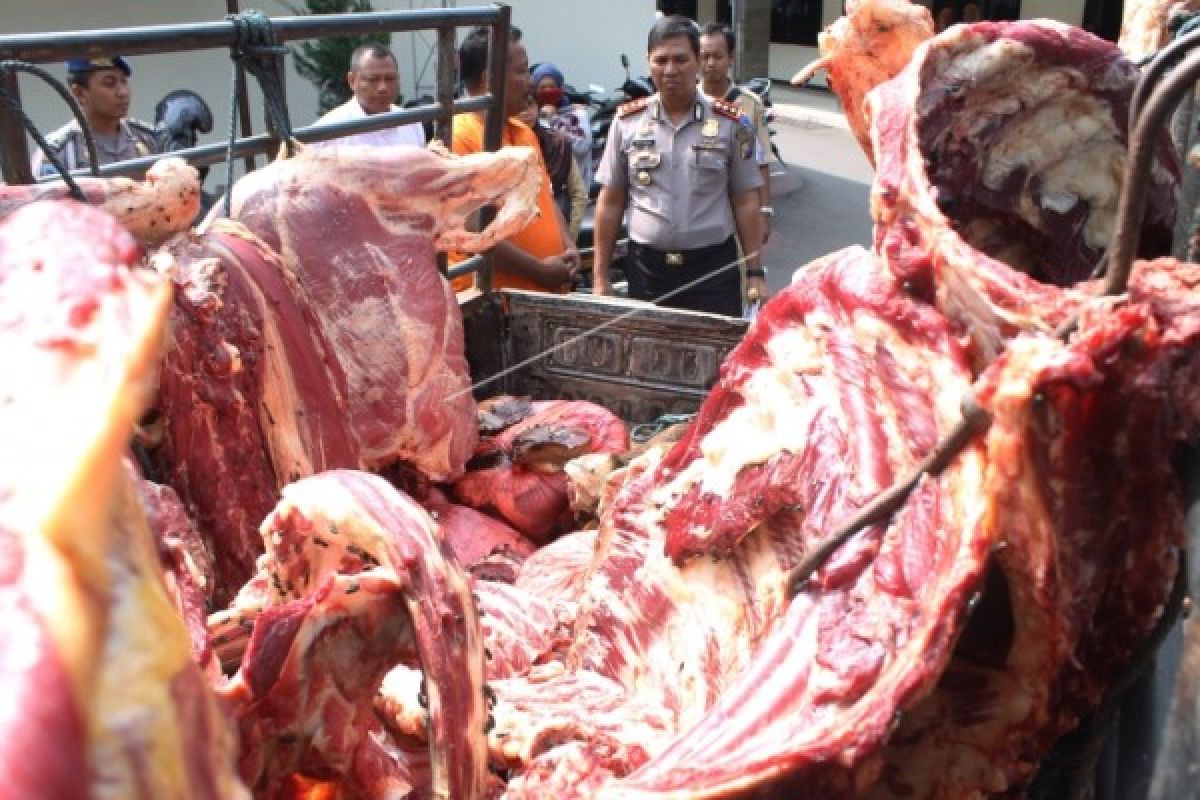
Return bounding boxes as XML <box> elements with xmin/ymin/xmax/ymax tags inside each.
<box><xmin>593</xmin><ymin>16</ymin><xmax>766</xmax><ymax>317</ymax></box>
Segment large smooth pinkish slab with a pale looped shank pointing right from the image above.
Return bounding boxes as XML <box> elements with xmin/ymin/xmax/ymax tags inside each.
<box><xmin>224</xmin><ymin>146</ymin><xmax>539</xmax><ymax>481</ymax></box>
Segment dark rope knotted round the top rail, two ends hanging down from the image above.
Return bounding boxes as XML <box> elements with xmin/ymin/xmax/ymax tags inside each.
<box><xmin>224</xmin><ymin>10</ymin><xmax>296</xmax><ymax>216</ymax></box>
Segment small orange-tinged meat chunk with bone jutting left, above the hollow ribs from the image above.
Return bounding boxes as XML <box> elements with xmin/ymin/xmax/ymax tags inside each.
<box><xmin>792</xmin><ymin>0</ymin><xmax>934</xmax><ymax>164</ymax></box>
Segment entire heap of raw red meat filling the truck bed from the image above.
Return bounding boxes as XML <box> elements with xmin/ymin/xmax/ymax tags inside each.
<box><xmin>0</xmin><ymin>0</ymin><xmax>1200</xmax><ymax>800</ymax></box>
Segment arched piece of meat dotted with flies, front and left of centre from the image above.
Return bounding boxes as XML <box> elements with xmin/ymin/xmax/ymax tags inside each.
<box><xmin>222</xmin><ymin>470</ymin><xmax>487</xmax><ymax>799</ymax></box>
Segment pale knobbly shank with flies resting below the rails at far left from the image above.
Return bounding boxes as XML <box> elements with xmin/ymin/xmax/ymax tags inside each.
<box><xmin>0</xmin><ymin>157</ymin><xmax>200</xmax><ymax>247</ymax></box>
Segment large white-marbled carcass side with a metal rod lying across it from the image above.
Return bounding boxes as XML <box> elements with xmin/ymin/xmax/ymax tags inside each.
<box><xmin>376</xmin><ymin>249</ymin><xmax>988</xmax><ymax>799</ymax></box>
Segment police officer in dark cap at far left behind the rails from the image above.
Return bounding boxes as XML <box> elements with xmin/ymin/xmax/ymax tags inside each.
<box><xmin>34</xmin><ymin>55</ymin><xmax>161</xmax><ymax>178</ymax></box>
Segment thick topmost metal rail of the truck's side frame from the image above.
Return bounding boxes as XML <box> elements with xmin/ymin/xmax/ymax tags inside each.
<box><xmin>0</xmin><ymin>5</ymin><xmax>509</xmax><ymax>62</ymax></box>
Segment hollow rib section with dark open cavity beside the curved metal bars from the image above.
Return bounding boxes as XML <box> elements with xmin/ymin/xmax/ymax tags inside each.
<box><xmin>868</xmin><ymin>20</ymin><xmax>1178</xmax><ymax>365</ymax></box>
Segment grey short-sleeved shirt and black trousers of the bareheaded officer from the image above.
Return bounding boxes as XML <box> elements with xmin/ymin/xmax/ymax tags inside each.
<box><xmin>596</xmin><ymin>91</ymin><xmax>762</xmax><ymax>317</ymax></box>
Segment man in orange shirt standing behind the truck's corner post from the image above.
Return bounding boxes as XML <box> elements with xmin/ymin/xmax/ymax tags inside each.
<box><xmin>451</xmin><ymin>28</ymin><xmax>580</xmax><ymax>291</ymax></box>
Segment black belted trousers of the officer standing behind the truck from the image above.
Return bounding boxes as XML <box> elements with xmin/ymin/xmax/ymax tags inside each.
<box><xmin>625</xmin><ymin>236</ymin><xmax>743</xmax><ymax>317</ymax></box>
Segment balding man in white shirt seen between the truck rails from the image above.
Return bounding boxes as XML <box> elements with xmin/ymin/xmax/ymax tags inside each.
<box><xmin>317</xmin><ymin>44</ymin><xmax>425</xmax><ymax>148</ymax></box>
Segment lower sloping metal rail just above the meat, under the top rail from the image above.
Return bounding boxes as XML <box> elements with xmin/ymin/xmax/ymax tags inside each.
<box><xmin>72</xmin><ymin>96</ymin><xmax>491</xmax><ymax>175</ymax></box>
